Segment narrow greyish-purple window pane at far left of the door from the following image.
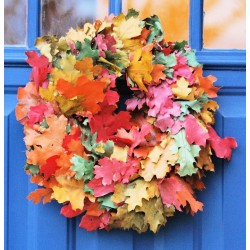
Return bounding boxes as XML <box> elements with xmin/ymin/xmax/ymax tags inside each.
<box><xmin>4</xmin><ymin>0</ymin><xmax>27</xmax><ymax>45</ymax></box>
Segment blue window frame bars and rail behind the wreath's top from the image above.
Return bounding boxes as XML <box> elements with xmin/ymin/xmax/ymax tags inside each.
<box><xmin>4</xmin><ymin>0</ymin><xmax>246</xmax><ymax>69</ymax></box>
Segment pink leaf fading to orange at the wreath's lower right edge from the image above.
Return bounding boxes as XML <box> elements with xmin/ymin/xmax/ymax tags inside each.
<box><xmin>158</xmin><ymin>175</ymin><xmax>203</xmax><ymax>214</ymax></box>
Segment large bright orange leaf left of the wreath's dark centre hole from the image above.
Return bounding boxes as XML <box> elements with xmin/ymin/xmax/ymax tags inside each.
<box><xmin>56</xmin><ymin>75</ymin><xmax>106</xmax><ymax>114</ymax></box>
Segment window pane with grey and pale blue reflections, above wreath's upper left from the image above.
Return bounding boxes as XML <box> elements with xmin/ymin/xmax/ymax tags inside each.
<box><xmin>41</xmin><ymin>0</ymin><xmax>108</xmax><ymax>36</ymax></box>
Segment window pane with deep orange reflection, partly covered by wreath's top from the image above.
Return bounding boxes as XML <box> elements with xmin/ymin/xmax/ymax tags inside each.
<box><xmin>123</xmin><ymin>0</ymin><xmax>189</xmax><ymax>41</ymax></box>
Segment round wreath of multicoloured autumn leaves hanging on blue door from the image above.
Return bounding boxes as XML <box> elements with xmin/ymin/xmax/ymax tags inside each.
<box><xmin>16</xmin><ymin>9</ymin><xmax>237</xmax><ymax>233</ymax></box>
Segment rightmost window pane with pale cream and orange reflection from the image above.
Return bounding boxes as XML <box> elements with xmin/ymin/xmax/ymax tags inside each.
<box><xmin>204</xmin><ymin>0</ymin><xmax>246</xmax><ymax>49</ymax></box>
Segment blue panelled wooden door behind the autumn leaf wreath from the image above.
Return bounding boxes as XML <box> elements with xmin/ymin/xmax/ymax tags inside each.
<box><xmin>4</xmin><ymin>0</ymin><xmax>246</xmax><ymax>250</ymax></box>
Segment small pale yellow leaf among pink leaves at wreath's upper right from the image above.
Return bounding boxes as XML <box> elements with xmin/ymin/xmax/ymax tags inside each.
<box><xmin>172</xmin><ymin>77</ymin><xmax>194</xmax><ymax>100</ymax></box>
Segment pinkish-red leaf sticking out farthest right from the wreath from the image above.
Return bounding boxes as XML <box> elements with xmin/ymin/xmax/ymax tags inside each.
<box><xmin>208</xmin><ymin>126</ymin><xmax>238</xmax><ymax>160</ymax></box>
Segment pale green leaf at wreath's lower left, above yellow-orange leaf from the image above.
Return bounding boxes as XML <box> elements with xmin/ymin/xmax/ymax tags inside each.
<box><xmin>70</xmin><ymin>155</ymin><xmax>95</xmax><ymax>181</ymax></box>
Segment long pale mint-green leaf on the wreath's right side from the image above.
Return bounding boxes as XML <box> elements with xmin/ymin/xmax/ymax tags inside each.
<box><xmin>171</xmin><ymin>129</ymin><xmax>200</xmax><ymax>176</ymax></box>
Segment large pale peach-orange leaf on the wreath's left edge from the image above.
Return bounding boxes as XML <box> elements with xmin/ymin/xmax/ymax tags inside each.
<box><xmin>24</xmin><ymin>115</ymin><xmax>67</xmax><ymax>165</ymax></box>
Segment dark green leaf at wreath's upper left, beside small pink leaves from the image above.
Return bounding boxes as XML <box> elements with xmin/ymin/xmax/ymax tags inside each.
<box><xmin>75</xmin><ymin>38</ymin><xmax>99</xmax><ymax>60</ymax></box>
